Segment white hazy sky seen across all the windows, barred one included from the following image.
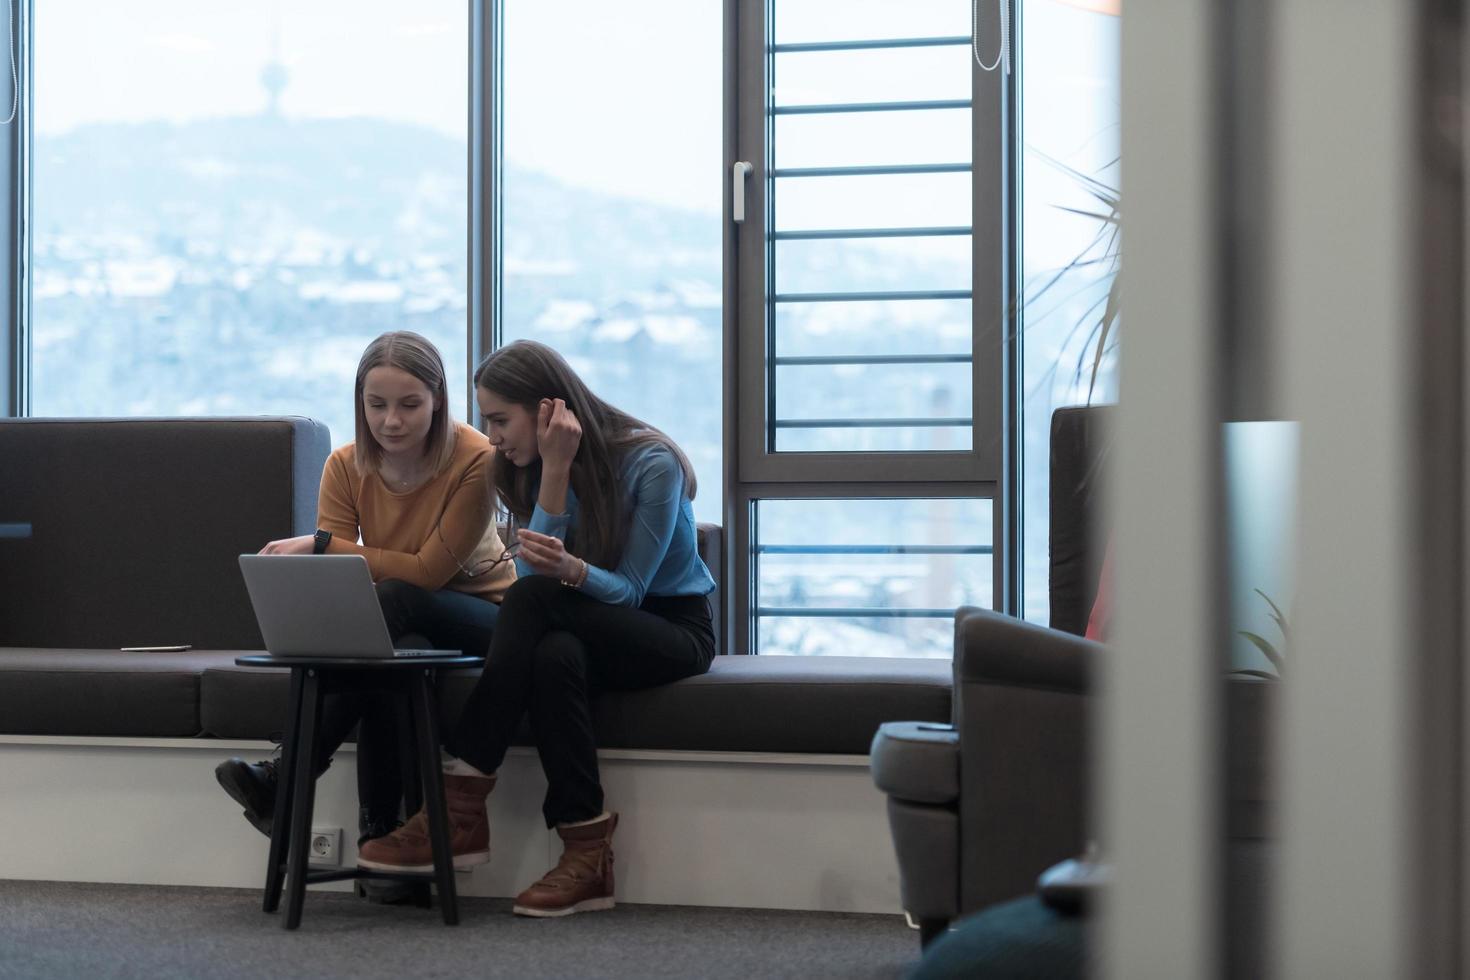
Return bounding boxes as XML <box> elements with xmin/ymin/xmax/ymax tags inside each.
<box><xmin>34</xmin><ymin>0</ymin><xmax>1117</xmax><ymax>243</ymax></box>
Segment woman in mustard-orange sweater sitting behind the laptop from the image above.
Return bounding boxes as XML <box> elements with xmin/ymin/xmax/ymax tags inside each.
<box><xmin>215</xmin><ymin>331</ymin><xmax>515</xmax><ymax>869</ymax></box>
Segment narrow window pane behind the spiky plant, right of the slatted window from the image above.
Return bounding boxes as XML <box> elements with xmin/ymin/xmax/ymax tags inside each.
<box><xmin>1020</xmin><ymin>0</ymin><xmax>1120</xmax><ymax>623</ymax></box>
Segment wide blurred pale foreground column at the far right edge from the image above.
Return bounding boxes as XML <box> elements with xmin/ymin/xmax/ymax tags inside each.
<box><xmin>1272</xmin><ymin>0</ymin><xmax>1466</xmax><ymax>977</ymax></box>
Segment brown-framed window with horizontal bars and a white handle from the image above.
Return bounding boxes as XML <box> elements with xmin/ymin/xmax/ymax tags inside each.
<box><xmin>735</xmin><ymin>0</ymin><xmax>1010</xmax><ymax>657</ymax></box>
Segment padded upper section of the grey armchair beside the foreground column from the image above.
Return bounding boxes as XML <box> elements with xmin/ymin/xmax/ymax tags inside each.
<box><xmin>954</xmin><ymin>607</ymin><xmax>1104</xmax><ymax>696</ymax></box>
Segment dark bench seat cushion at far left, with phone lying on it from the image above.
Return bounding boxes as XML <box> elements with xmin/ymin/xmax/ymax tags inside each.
<box><xmin>0</xmin><ymin>648</ymin><xmax>245</xmax><ymax>738</ymax></box>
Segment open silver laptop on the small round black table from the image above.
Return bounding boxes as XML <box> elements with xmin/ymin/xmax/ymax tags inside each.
<box><xmin>240</xmin><ymin>555</ymin><xmax>435</xmax><ymax>658</ymax></box>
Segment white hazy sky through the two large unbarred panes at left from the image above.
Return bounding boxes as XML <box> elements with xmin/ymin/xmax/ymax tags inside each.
<box><xmin>35</xmin><ymin>0</ymin><xmax>723</xmax><ymax>210</ymax></box>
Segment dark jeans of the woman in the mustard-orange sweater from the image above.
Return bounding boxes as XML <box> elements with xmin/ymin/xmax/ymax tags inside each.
<box><xmin>316</xmin><ymin>579</ymin><xmax>500</xmax><ymax>821</ymax></box>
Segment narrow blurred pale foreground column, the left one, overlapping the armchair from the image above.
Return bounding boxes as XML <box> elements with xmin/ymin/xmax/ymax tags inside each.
<box><xmin>1094</xmin><ymin>0</ymin><xmax>1222</xmax><ymax>980</ymax></box>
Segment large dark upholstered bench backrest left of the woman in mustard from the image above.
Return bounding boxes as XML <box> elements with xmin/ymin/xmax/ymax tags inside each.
<box><xmin>0</xmin><ymin>419</ymin><xmax>331</xmax><ymax>649</ymax></box>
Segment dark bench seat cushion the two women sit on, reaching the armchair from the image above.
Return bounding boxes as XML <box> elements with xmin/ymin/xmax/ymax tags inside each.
<box><xmin>200</xmin><ymin>657</ymin><xmax>951</xmax><ymax>755</ymax></box>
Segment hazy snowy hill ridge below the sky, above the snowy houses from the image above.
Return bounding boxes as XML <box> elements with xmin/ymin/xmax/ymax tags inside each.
<box><xmin>34</xmin><ymin>116</ymin><xmax>967</xmax><ymax>302</ymax></box>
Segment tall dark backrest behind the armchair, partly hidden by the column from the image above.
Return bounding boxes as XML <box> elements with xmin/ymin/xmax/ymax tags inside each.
<box><xmin>1048</xmin><ymin>406</ymin><xmax>1111</xmax><ymax>636</ymax></box>
